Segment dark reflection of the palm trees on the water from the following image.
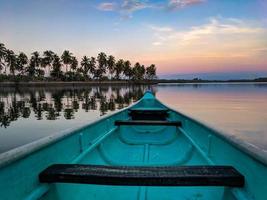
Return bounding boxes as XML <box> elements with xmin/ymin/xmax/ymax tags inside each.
<box><xmin>0</xmin><ymin>86</ymin><xmax>153</xmax><ymax>128</ymax></box>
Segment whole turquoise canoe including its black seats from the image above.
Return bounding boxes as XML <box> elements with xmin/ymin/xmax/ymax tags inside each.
<box><xmin>0</xmin><ymin>92</ymin><xmax>267</xmax><ymax>200</ymax></box>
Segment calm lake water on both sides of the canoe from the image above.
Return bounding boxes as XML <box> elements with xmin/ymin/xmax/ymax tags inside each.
<box><xmin>0</xmin><ymin>84</ymin><xmax>267</xmax><ymax>152</ymax></box>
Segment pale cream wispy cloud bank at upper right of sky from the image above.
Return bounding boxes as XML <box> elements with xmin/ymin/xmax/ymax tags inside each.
<box><xmin>152</xmin><ymin>18</ymin><xmax>266</xmax><ymax>44</ymax></box>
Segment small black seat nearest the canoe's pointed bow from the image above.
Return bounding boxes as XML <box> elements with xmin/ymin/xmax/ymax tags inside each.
<box><xmin>129</xmin><ymin>109</ymin><xmax>169</xmax><ymax>120</ymax></box>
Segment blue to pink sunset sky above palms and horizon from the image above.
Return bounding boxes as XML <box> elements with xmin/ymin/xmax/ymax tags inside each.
<box><xmin>0</xmin><ymin>0</ymin><xmax>267</xmax><ymax>78</ymax></box>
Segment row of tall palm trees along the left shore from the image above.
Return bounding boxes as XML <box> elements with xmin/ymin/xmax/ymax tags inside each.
<box><xmin>0</xmin><ymin>43</ymin><xmax>157</xmax><ymax>81</ymax></box>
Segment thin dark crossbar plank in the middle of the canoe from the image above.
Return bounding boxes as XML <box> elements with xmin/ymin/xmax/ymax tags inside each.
<box><xmin>115</xmin><ymin>120</ymin><xmax>182</xmax><ymax>126</ymax></box>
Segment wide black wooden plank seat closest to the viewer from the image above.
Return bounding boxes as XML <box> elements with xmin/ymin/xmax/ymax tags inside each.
<box><xmin>39</xmin><ymin>164</ymin><xmax>245</xmax><ymax>187</ymax></box>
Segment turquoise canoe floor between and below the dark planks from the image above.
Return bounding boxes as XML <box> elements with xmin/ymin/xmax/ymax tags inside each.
<box><xmin>42</xmin><ymin>126</ymin><xmax>239</xmax><ymax>200</ymax></box>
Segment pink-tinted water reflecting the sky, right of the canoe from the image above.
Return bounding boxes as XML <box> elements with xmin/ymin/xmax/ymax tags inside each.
<box><xmin>157</xmin><ymin>84</ymin><xmax>267</xmax><ymax>151</ymax></box>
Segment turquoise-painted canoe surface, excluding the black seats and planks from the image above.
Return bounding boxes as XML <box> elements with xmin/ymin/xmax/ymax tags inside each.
<box><xmin>0</xmin><ymin>92</ymin><xmax>267</xmax><ymax>200</ymax></box>
